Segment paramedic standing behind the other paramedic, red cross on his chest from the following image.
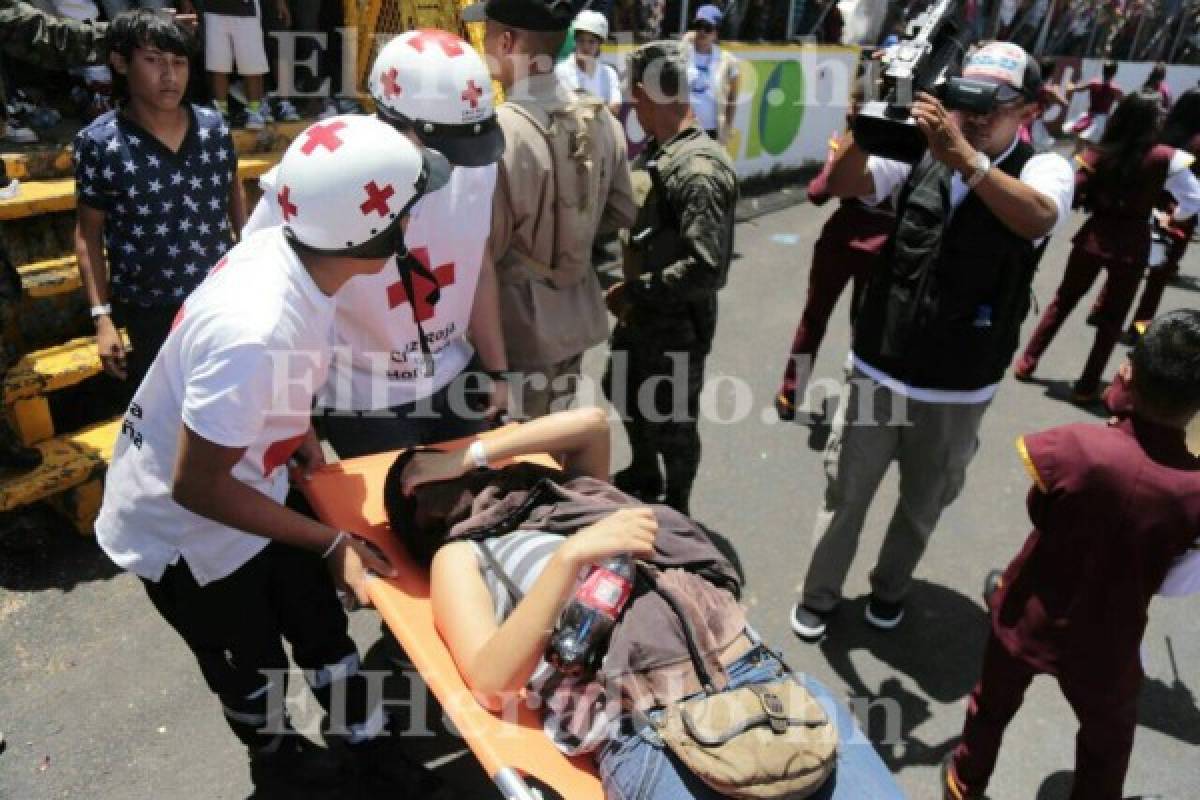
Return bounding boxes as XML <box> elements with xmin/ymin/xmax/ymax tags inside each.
<box><xmin>245</xmin><ymin>30</ymin><xmax>508</xmax><ymax>458</ymax></box>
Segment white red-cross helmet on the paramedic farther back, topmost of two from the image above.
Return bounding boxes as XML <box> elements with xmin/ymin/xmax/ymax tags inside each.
<box><xmin>367</xmin><ymin>28</ymin><xmax>504</xmax><ymax>167</ymax></box>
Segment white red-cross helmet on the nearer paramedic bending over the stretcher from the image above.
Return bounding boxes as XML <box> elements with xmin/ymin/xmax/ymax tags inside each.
<box><xmin>276</xmin><ymin>114</ymin><xmax>450</xmax><ymax>258</ymax></box>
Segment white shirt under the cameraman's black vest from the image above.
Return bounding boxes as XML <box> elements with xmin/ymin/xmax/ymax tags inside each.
<box><xmin>851</xmin><ymin>138</ymin><xmax>1075</xmax><ymax>403</ymax></box>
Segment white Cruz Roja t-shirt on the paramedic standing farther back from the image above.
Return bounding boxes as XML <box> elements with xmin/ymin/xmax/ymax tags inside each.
<box><xmin>246</xmin><ymin>166</ymin><xmax>496</xmax><ymax>411</ymax></box>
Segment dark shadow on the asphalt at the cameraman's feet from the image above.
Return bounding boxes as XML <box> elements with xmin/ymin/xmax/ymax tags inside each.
<box><xmin>800</xmin><ymin>581</ymin><xmax>988</xmax><ymax>770</ymax></box>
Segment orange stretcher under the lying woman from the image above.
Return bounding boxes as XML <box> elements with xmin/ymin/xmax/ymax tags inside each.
<box><xmin>299</xmin><ymin>443</ymin><xmax>604</xmax><ymax>800</ymax></box>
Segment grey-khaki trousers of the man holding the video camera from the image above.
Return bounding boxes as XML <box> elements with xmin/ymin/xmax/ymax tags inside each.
<box><xmin>803</xmin><ymin>369</ymin><xmax>989</xmax><ymax>612</ymax></box>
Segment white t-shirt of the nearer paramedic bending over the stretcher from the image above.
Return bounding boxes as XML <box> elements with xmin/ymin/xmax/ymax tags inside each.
<box><xmin>96</xmin><ymin>228</ymin><xmax>335</xmax><ymax>585</ymax></box>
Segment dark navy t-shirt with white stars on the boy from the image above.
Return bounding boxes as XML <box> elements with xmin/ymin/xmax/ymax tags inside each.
<box><xmin>74</xmin><ymin>106</ymin><xmax>238</xmax><ymax>307</ymax></box>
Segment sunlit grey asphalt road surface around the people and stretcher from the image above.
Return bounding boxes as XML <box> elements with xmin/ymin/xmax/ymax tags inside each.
<box><xmin>0</xmin><ymin>189</ymin><xmax>1200</xmax><ymax>800</ymax></box>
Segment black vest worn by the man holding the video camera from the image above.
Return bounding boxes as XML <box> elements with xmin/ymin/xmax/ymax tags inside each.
<box><xmin>854</xmin><ymin>142</ymin><xmax>1044</xmax><ymax>391</ymax></box>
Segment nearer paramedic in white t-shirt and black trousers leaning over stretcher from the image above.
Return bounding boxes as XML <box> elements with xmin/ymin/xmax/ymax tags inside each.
<box><xmin>96</xmin><ymin>116</ymin><xmax>449</xmax><ymax>787</ymax></box>
